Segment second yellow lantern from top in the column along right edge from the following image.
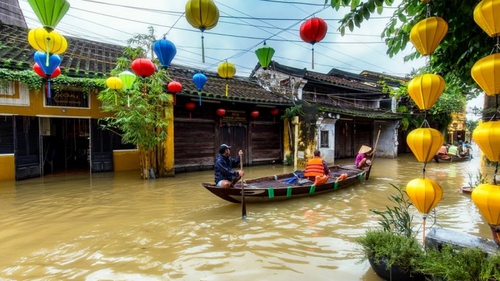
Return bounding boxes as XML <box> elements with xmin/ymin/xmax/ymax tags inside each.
<box><xmin>470</xmin><ymin>53</ymin><xmax>500</xmax><ymax>96</ymax></box>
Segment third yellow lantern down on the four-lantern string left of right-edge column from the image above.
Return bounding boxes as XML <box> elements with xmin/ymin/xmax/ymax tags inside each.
<box><xmin>406</xmin><ymin>128</ymin><xmax>444</xmax><ymax>163</ymax></box>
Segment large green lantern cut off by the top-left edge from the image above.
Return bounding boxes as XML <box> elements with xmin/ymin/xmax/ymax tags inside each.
<box><xmin>28</xmin><ymin>0</ymin><xmax>69</xmax><ymax>32</ymax></box>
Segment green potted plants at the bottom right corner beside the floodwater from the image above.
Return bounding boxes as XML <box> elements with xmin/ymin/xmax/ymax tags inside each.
<box><xmin>356</xmin><ymin>183</ymin><xmax>500</xmax><ymax>281</ymax></box>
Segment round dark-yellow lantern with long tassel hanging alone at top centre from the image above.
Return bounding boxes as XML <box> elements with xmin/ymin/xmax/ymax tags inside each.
<box><xmin>186</xmin><ymin>0</ymin><xmax>219</xmax><ymax>63</ymax></box>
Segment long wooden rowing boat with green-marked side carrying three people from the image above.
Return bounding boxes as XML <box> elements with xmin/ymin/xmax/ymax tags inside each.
<box><xmin>202</xmin><ymin>165</ymin><xmax>368</xmax><ymax>203</ymax></box>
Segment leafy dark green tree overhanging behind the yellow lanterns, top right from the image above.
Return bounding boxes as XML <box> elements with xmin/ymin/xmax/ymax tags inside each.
<box><xmin>325</xmin><ymin>0</ymin><xmax>496</xmax><ymax>98</ymax></box>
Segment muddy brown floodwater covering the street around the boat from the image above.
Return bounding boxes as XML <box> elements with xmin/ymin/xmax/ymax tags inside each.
<box><xmin>0</xmin><ymin>151</ymin><xmax>493</xmax><ymax>281</ymax></box>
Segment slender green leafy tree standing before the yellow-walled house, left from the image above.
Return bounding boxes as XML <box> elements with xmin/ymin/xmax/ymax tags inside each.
<box><xmin>99</xmin><ymin>27</ymin><xmax>171</xmax><ymax>179</ymax></box>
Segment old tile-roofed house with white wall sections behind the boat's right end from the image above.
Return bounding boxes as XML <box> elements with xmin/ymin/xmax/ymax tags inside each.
<box><xmin>252</xmin><ymin>62</ymin><xmax>400</xmax><ymax>166</ymax></box>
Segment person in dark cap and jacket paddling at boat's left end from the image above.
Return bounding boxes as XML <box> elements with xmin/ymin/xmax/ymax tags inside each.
<box><xmin>214</xmin><ymin>144</ymin><xmax>245</xmax><ymax>188</ymax></box>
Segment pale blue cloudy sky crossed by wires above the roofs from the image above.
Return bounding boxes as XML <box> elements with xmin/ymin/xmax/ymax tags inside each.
<box><xmin>19</xmin><ymin>0</ymin><xmax>425</xmax><ymax>76</ymax></box>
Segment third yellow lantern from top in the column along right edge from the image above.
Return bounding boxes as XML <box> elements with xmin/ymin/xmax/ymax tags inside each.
<box><xmin>472</xmin><ymin>121</ymin><xmax>500</xmax><ymax>162</ymax></box>
